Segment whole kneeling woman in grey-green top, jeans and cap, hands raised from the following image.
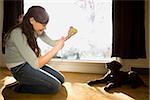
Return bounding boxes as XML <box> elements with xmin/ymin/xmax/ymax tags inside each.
<box><xmin>5</xmin><ymin>6</ymin><xmax>77</xmax><ymax>93</ymax></box>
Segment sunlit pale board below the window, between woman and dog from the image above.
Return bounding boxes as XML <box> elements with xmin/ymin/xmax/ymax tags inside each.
<box><xmin>48</xmin><ymin>61</ymin><xmax>107</xmax><ymax>74</ymax></box>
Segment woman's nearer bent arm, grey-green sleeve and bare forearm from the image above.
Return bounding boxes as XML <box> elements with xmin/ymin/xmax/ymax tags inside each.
<box><xmin>11</xmin><ymin>29</ymin><xmax>65</xmax><ymax>69</ymax></box>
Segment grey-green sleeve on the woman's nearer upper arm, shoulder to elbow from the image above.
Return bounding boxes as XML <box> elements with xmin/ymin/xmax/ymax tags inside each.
<box><xmin>10</xmin><ymin>28</ymin><xmax>38</xmax><ymax>69</ymax></box>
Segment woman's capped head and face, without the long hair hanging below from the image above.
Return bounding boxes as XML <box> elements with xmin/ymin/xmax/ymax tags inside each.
<box><xmin>23</xmin><ymin>6</ymin><xmax>49</xmax><ymax>35</ymax></box>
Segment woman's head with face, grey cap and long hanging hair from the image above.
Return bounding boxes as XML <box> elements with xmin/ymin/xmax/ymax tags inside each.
<box><xmin>21</xmin><ymin>6</ymin><xmax>49</xmax><ymax>56</ymax></box>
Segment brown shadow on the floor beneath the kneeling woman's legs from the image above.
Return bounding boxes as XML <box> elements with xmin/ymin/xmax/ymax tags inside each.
<box><xmin>2</xmin><ymin>86</ymin><xmax>67</xmax><ymax>100</ymax></box>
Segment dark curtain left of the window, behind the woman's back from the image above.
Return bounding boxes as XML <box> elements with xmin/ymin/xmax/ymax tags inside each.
<box><xmin>2</xmin><ymin>0</ymin><xmax>24</xmax><ymax>53</ymax></box>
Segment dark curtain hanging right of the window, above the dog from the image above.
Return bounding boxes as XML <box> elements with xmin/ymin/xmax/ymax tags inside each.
<box><xmin>112</xmin><ymin>0</ymin><xmax>146</xmax><ymax>59</ymax></box>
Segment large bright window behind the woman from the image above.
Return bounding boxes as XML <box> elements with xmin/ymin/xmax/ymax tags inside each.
<box><xmin>24</xmin><ymin>0</ymin><xmax>112</xmax><ymax>60</ymax></box>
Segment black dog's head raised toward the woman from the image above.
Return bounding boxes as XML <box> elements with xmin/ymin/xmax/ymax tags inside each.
<box><xmin>106</xmin><ymin>61</ymin><xmax>122</xmax><ymax>72</ymax></box>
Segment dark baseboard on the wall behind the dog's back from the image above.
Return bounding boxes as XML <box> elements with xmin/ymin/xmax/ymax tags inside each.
<box><xmin>131</xmin><ymin>67</ymin><xmax>150</xmax><ymax>75</ymax></box>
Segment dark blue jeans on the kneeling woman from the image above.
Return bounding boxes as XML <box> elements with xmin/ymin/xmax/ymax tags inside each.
<box><xmin>11</xmin><ymin>63</ymin><xmax>64</xmax><ymax>94</ymax></box>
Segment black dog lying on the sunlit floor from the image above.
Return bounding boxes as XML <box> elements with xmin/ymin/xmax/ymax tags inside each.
<box><xmin>88</xmin><ymin>61</ymin><xmax>144</xmax><ymax>92</ymax></box>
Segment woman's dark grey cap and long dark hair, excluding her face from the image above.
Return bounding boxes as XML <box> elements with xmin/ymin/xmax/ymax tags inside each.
<box><xmin>5</xmin><ymin>6</ymin><xmax>49</xmax><ymax>57</ymax></box>
